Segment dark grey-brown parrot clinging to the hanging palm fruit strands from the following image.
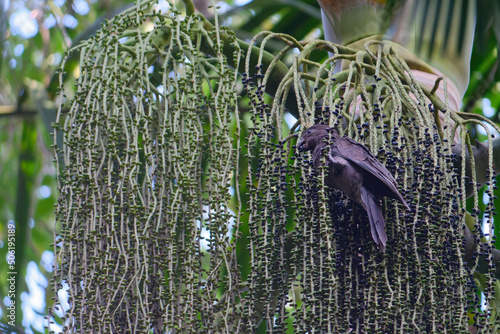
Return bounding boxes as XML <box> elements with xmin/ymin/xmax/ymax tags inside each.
<box><xmin>297</xmin><ymin>124</ymin><xmax>409</xmax><ymax>252</ymax></box>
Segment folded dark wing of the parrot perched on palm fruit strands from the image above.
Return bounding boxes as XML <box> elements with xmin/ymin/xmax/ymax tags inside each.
<box><xmin>330</xmin><ymin>137</ymin><xmax>408</xmax><ymax>208</ymax></box>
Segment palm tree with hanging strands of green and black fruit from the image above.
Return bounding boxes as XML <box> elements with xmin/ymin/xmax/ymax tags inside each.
<box><xmin>0</xmin><ymin>0</ymin><xmax>498</xmax><ymax>333</ymax></box>
